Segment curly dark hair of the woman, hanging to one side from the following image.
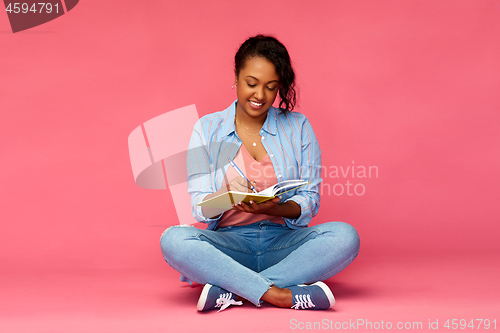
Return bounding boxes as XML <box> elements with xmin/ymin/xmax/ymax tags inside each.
<box><xmin>234</xmin><ymin>35</ymin><xmax>297</xmax><ymax>112</ymax></box>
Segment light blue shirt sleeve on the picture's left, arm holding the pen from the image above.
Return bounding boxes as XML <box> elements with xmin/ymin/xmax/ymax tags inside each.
<box><xmin>186</xmin><ymin>120</ymin><xmax>222</xmax><ymax>223</ymax></box>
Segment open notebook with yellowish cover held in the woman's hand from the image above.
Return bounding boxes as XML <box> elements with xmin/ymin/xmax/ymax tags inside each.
<box><xmin>198</xmin><ymin>179</ymin><xmax>309</xmax><ymax>210</ymax></box>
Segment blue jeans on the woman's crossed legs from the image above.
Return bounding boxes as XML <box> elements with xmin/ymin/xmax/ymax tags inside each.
<box><xmin>160</xmin><ymin>221</ymin><xmax>359</xmax><ymax>305</ymax></box>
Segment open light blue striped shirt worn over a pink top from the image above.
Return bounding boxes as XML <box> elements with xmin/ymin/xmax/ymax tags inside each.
<box><xmin>187</xmin><ymin>101</ymin><xmax>322</xmax><ymax>230</ymax></box>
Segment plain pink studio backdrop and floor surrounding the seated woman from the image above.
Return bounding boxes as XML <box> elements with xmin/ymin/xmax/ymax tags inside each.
<box><xmin>0</xmin><ymin>0</ymin><xmax>500</xmax><ymax>332</ymax></box>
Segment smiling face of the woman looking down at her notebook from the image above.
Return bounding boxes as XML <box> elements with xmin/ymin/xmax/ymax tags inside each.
<box><xmin>236</xmin><ymin>57</ymin><xmax>279</xmax><ymax>120</ymax></box>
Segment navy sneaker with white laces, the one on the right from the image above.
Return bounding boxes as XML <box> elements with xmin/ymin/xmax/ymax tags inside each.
<box><xmin>287</xmin><ymin>282</ymin><xmax>335</xmax><ymax>310</ymax></box>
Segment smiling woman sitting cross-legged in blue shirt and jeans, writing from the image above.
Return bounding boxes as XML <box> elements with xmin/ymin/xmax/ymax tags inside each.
<box><xmin>161</xmin><ymin>35</ymin><xmax>359</xmax><ymax>311</ymax></box>
